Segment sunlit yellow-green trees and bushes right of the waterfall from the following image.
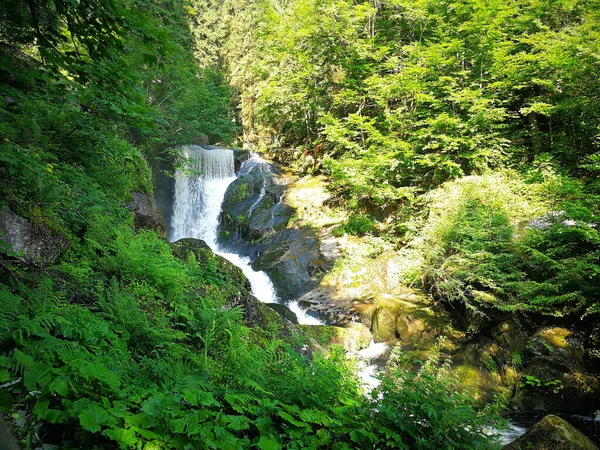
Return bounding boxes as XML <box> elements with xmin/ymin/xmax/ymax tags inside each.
<box><xmin>202</xmin><ymin>0</ymin><xmax>600</xmax><ymax>324</ymax></box>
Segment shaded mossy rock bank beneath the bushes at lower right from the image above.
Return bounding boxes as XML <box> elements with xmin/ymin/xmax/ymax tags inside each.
<box><xmin>452</xmin><ymin>314</ymin><xmax>600</xmax><ymax>414</ymax></box>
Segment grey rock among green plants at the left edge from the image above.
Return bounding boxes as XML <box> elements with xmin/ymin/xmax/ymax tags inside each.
<box><xmin>0</xmin><ymin>206</ymin><xmax>71</xmax><ymax>266</ymax></box>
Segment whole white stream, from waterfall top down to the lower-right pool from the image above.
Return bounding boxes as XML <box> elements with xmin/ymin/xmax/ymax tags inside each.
<box><xmin>164</xmin><ymin>145</ymin><xmax>597</xmax><ymax>444</ymax></box>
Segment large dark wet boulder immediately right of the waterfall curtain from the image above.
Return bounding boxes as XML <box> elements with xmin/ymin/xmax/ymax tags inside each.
<box><xmin>219</xmin><ymin>161</ymin><xmax>326</xmax><ymax>300</ymax></box>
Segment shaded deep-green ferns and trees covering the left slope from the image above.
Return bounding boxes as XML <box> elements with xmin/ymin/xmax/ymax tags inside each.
<box><xmin>0</xmin><ymin>0</ymin><xmax>504</xmax><ymax>449</ymax></box>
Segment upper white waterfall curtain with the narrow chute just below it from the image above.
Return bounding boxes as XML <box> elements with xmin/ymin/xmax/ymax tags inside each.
<box><xmin>169</xmin><ymin>145</ymin><xmax>321</xmax><ymax>324</ymax></box>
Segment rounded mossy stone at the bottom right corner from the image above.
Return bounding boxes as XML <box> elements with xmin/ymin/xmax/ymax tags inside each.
<box><xmin>504</xmin><ymin>415</ymin><xmax>598</xmax><ymax>450</ymax></box>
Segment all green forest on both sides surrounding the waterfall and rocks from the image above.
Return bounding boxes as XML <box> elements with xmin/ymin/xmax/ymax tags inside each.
<box><xmin>0</xmin><ymin>0</ymin><xmax>600</xmax><ymax>450</ymax></box>
